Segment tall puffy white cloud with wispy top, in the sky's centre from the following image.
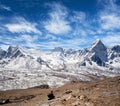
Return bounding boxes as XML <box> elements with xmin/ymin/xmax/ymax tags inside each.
<box><xmin>44</xmin><ymin>3</ymin><xmax>71</xmax><ymax>34</ymax></box>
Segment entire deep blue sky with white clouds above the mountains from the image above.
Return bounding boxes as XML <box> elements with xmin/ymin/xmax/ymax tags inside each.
<box><xmin>0</xmin><ymin>0</ymin><xmax>120</xmax><ymax>50</ymax></box>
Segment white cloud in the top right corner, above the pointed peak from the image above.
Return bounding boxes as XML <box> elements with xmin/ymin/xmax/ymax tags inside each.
<box><xmin>99</xmin><ymin>0</ymin><xmax>120</xmax><ymax>30</ymax></box>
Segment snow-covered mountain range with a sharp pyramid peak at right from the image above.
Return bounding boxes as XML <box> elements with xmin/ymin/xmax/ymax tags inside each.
<box><xmin>0</xmin><ymin>40</ymin><xmax>120</xmax><ymax>90</ymax></box>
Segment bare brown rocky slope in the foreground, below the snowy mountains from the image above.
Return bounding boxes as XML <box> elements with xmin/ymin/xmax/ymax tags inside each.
<box><xmin>0</xmin><ymin>76</ymin><xmax>120</xmax><ymax>106</ymax></box>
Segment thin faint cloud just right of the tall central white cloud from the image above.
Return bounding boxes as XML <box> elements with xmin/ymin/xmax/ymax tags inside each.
<box><xmin>70</xmin><ymin>11</ymin><xmax>93</xmax><ymax>37</ymax></box>
